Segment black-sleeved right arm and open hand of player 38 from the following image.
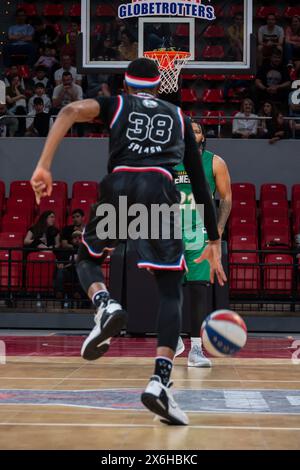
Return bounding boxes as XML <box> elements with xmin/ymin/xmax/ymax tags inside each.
<box><xmin>184</xmin><ymin>119</ymin><xmax>227</xmax><ymax>286</ymax></box>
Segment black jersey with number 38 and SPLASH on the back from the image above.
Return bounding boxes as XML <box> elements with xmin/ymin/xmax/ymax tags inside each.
<box><xmin>97</xmin><ymin>93</ymin><xmax>185</xmax><ymax>171</ymax></box>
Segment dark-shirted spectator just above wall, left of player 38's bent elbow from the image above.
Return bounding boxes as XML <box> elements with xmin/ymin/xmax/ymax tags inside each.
<box><xmin>25</xmin><ymin>97</ymin><xmax>51</xmax><ymax>137</ymax></box>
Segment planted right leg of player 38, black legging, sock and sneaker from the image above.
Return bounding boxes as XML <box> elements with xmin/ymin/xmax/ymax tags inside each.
<box><xmin>141</xmin><ymin>271</ymin><xmax>188</xmax><ymax>425</ymax></box>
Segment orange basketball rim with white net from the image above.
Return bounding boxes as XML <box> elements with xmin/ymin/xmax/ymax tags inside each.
<box><xmin>144</xmin><ymin>49</ymin><xmax>191</xmax><ymax>93</ymax></box>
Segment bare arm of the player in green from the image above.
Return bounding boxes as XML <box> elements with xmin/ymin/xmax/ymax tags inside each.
<box><xmin>213</xmin><ymin>155</ymin><xmax>232</xmax><ymax>237</ymax></box>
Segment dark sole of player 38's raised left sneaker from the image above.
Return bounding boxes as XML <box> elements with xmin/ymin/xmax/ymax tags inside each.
<box><xmin>81</xmin><ymin>310</ymin><xmax>127</xmax><ymax>361</ymax></box>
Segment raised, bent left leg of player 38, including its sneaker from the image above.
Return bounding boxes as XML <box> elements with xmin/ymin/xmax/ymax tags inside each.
<box><xmin>77</xmin><ymin>245</ymin><xmax>127</xmax><ymax>361</ymax></box>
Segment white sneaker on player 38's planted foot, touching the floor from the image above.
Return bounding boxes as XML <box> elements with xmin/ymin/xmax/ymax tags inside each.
<box><xmin>141</xmin><ymin>375</ymin><xmax>189</xmax><ymax>426</ymax></box>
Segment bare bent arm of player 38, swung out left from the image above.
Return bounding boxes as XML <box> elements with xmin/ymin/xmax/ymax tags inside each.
<box><xmin>31</xmin><ymin>99</ymin><xmax>100</xmax><ymax>204</ymax></box>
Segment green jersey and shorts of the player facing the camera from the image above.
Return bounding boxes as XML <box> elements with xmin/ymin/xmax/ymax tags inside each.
<box><xmin>175</xmin><ymin>150</ymin><xmax>216</xmax><ymax>281</ymax></box>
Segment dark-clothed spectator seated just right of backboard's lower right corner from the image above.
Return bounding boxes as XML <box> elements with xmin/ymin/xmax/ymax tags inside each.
<box><xmin>255</xmin><ymin>49</ymin><xmax>291</xmax><ymax>107</ymax></box>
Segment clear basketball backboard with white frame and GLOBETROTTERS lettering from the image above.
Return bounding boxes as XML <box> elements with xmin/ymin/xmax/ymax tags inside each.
<box><xmin>77</xmin><ymin>0</ymin><xmax>255</xmax><ymax>73</ymax></box>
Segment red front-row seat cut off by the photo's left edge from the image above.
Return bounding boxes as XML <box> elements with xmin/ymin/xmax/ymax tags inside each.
<box><xmin>0</xmin><ymin>250</ymin><xmax>23</xmax><ymax>291</ymax></box>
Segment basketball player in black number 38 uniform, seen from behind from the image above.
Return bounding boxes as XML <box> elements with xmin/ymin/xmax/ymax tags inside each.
<box><xmin>31</xmin><ymin>59</ymin><xmax>226</xmax><ymax>425</ymax></box>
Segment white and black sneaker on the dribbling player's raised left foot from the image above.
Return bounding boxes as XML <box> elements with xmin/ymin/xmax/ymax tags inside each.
<box><xmin>81</xmin><ymin>299</ymin><xmax>127</xmax><ymax>361</ymax></box>
